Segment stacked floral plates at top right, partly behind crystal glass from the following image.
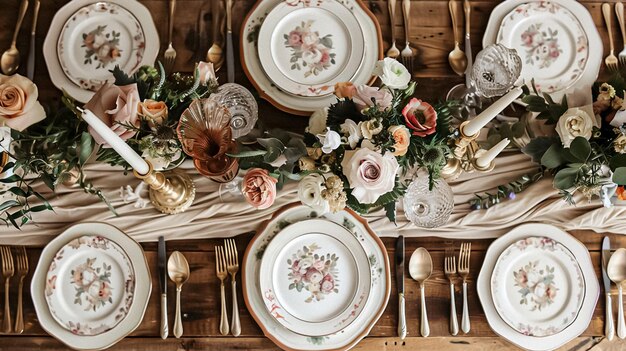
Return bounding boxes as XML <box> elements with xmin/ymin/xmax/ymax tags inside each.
<box><xmin>483</xmin><ymin>0</ymin><xmax>602</xmax><ymax>101</ymax></box>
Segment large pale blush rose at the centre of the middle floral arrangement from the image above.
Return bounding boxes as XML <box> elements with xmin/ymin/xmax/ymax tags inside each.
<box><xmin>341</xmin><ymin>148</ymin><xmax>400</xmax><ymax>204</ymax></box>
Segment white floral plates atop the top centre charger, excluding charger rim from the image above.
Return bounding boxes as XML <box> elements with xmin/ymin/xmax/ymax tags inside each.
<box><xmin>258</xmin><ymin>1</ymin><xmax>365</xmax><ymax>96</ymax></box>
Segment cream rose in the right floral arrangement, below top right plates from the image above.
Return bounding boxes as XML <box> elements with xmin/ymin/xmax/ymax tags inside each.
<box><xmin>556</xmin><ymin>106</ymin><xmax>597</xmax><ymax>148</ymax></box>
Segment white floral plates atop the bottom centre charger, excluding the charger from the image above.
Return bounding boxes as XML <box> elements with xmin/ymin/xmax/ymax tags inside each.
<box><xmin>259</xmin><ymin>219</ymin><xmax>371</xmax><ymax>336</ymax></box>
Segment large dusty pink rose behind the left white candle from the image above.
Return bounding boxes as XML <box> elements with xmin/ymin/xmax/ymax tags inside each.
<box><xmin>85</xmin><ymin>83</ymin><xmax>140</xmax><ymax>147</ymax></box>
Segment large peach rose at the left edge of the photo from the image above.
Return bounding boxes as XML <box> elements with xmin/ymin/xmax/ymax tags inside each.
<box><xmin>0</xmin><ymin>74</ymin><xmax>46</xmax><ymax>132</ymax></box>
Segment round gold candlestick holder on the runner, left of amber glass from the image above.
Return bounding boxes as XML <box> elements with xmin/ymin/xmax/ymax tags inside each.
<box><xmin>133</xmin><ymin>161</ymin><xmax>196</xmax><ymax>214</ymax></box>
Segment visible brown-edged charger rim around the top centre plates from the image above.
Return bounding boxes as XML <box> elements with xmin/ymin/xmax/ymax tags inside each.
<box><xmin>240</xmin><ymin>0</ymin><xmax>383</xmax><ymax>116</ymax></box>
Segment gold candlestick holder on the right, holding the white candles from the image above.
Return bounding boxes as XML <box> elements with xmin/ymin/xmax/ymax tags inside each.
<box><xmin>441</xmin><ymin>121</ymin><xmax>495</xmax><ymax>180</ymax></box>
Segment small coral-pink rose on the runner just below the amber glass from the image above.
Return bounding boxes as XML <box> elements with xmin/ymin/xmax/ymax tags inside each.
<box><xmin>241</xmin><ymin>168</ymin><xmax>278</xmax><ymax>210</ymax></box>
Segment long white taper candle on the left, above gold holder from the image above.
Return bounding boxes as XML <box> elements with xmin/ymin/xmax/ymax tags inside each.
<box><xmin>81</xmin><ymin>110</ymin><xmax>150</xmax><ymax>175</ymax></box>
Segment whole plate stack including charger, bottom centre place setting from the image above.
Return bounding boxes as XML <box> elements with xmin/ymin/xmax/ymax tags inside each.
<box><xmin>243</xmin><ymin>204</ymin><xmax>390</xmax><ymax>350</ymax></box>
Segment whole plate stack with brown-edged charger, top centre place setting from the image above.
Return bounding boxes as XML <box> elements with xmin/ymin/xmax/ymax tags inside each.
<box><xmin>241</xmin><ymin>0</ymin><xmax>382</xmax><ymax>115</ymax></box>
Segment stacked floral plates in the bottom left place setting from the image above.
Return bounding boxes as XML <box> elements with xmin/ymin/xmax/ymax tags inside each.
<box><xmin>31</xmin><ymin>223</ymin><xmax>152</xmax><ymax>350</ymax></box>
